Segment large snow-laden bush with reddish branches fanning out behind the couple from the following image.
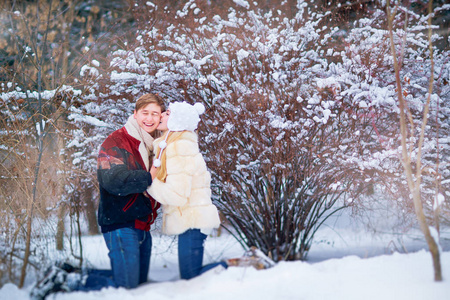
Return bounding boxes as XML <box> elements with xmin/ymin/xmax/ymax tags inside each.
<box><xmin>73</xmin><ymin>1</ymin><xmax>384</xmax><ymax>260</ymax></box>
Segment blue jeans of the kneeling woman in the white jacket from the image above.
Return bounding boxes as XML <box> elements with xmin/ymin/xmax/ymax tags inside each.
<box><xmin>178</xmin><ymin>229</ymin><xmax>228</xmax><ymax>279</ymax></box>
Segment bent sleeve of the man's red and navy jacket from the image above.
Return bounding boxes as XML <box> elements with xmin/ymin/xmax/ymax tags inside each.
<box><xmin>97</xmin><ymin>137</ymin><xmax>152</xmax><ymax>196</ymax></box>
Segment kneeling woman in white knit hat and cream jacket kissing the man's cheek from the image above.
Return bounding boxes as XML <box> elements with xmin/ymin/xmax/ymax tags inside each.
<box><xmin>147</xmin><ymin>102</ymin><xmax>228</xmax><ymax>279</ymax></box>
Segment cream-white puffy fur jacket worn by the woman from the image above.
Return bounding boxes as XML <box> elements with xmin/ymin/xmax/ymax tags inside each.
<box><xmin>147</xmin><ymin>131</ymin><xmax>220</xmax><ymax>235</ymax></box>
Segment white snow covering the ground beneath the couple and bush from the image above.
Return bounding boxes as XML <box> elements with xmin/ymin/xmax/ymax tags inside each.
<box><xmin>0</xmin><ymin>217</ymin><xmax>450</xmax><ymax>300</ymax></box>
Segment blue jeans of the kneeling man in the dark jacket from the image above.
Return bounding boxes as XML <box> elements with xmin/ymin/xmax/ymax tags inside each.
<box><xmin>75</xmin><ymin>228</ymin><xmax>152</xmax><ymax>291</ymax></box>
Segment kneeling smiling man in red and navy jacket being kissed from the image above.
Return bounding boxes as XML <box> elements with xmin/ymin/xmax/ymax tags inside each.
<box><xmin>31</xmin><ymin>94</ymin><xmax>165</xmax><ymax>299</ymax></box>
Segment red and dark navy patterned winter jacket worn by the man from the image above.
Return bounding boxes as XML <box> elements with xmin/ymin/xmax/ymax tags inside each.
<box><xmin>97</xmin><ymin>118</ymin><xmax>160</xmax><ymax>233</ymax></box>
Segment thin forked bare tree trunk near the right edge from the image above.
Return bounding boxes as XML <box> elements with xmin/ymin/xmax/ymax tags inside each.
<box><xmin>386</xmin><ymin>1</ymin><xmax>450</xmax><ymax>281</ymax></box>
